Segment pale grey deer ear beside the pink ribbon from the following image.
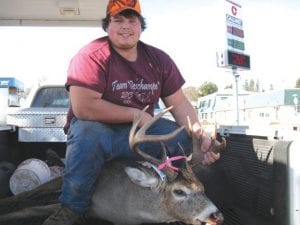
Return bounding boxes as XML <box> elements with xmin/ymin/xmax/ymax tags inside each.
<box><xmin>125</xmin><ymin>167</ymin><xmax>159</xmax><ymax>188</ymax></box>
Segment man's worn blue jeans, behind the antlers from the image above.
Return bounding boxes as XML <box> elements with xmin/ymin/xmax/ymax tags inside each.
<box><xmin>59</xmin><ymin>118</ymin><xmax>191</xmax><ymax>213</ymax></box>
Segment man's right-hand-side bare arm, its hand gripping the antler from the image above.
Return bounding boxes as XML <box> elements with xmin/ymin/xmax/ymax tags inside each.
<box><xmin>163</xmin><ymin>89</ymin><xmax>220</xmax><ymax>165</ymax></box>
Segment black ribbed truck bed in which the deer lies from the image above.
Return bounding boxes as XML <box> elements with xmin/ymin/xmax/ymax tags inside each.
<box><xmin>0</xmin><ymin>135</ymin><xmax>290</xmax><ymax>225</ymax></box>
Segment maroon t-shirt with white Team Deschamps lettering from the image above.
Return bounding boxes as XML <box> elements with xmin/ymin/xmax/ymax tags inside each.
<box><xmin>66</xmin><ymin>37</ymin><xmax>185</xmax><ymax>132</ymax></box>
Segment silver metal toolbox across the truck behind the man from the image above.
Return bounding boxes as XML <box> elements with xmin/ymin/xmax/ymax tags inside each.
<box><xmin>6</xmin><ymin>108</ymin><xmax>68</xmax><ymax>142</ymax></box>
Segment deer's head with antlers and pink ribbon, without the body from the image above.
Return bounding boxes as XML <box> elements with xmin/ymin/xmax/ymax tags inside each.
<box><xmin>126</xmin><ymin>108</ymin><xmax>223</xmax><ymax>225</ymax></box>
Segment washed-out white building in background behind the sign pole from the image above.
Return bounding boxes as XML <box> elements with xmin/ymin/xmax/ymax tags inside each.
<box><xmin>198</xmin><ymin>88</ymin><xmax>300</xmax><ymax>130</ymax></box>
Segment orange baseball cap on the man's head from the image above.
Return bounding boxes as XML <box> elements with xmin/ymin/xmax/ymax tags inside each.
<box><xmin>106</xmin><ymin>0</ymin><xmax>142</xmax><ymax>16</ymax></box>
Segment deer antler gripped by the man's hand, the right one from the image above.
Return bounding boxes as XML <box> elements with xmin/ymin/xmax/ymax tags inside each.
<box><xmin>187</xmin><ymin>117</ymin><xmax>226</xmax><ymax>166</ymax></box>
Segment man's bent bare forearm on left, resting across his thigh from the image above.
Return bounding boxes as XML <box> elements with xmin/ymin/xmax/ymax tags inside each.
<box><xmin>70</xmin><ymin>86</ymin><xmax>151</xmax><ymax>125</ymax></box>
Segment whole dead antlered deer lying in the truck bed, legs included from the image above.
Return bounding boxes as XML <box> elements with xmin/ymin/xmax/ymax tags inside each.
<box><xmin>0</xmin><ymin>108</ymin><xmax>226</xmax><ymax>225</ymax></box>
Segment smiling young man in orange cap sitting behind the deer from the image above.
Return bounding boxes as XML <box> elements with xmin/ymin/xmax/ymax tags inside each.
<box><xmin>44</xmin><ymin>0</ymin><xmax>219</xmax><ymax>225</ymax></box>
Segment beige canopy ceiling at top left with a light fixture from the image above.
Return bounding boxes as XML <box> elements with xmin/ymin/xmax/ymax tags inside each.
<box><xmin>0</xmin><ymin>0</ymin><xmax>107</xmax><ymax>27</ymax></box>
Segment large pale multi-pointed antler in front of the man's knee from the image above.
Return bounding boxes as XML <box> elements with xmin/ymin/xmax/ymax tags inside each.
<box><xmin>129</xmin><ymin>106</ymin><xmax>185</xmax><ymax>174</ymax></box>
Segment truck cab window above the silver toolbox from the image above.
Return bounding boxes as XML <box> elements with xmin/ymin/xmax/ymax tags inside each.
<box><xmin>31</xmin><ymin>87</ymin><xmax>69</xmax><ymax>108</ymax></box>
